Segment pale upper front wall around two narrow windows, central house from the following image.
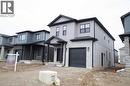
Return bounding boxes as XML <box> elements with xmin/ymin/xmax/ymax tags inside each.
<box><xmin>50</xmin><ymin>23</ymin><xmax>76</xmax><ymax>41</ymax></box>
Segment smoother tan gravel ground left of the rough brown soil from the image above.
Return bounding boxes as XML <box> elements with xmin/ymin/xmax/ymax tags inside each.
<box><xmin>0</xmin><ymin>63</ymin><xmax>89</xmax><ymax>86</ymax></box>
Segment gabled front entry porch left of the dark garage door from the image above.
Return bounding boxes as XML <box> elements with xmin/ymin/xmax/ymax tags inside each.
<box><xmin>46</xmin><ymin>36</ymin><xmax>67</xmax><ymax>66</ymax></box>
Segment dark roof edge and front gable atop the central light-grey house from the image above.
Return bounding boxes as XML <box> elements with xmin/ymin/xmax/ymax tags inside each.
<box><xmin>48</xmin><ymin>15</ymin><xmax>115</xmax><ymax>41</ymax></box>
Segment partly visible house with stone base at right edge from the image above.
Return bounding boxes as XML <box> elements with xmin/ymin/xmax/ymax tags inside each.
<box><xmin>119</xmin><ymin>12</ymin><xmax>130</xmax><ymax>64</ymax></box>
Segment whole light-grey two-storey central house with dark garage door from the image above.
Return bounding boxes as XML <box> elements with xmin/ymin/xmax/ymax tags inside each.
<box><xmin>46</xmin><ymin>15</ymin><xmax>115</xmax><ymax>68</ymax></box>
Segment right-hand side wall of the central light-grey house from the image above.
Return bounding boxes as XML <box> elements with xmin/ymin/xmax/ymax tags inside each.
<box><xmin>94</xmin><ymin>23</ymin><xmax>114</xmax><ymax>67</ymax></box>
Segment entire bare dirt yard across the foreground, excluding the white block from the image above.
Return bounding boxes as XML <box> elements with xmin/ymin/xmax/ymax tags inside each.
<box><xmin>0</xmin><ymin>63</ymin><xmax>130</xmax><ymax>86</ymax></box>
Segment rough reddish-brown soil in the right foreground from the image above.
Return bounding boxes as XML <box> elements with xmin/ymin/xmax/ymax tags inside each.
<box><xmin>81</xmin><ymin>69</ymin><xmax>130</xmax><ymax>86</ymax></box>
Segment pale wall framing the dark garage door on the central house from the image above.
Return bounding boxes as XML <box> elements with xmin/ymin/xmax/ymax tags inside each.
<box><xmin>65</xmin><ymin>41</ymin><xmax>92</xmax><ymax>69</ymax></box>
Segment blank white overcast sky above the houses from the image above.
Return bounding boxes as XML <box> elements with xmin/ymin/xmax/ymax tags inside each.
<box><xmin>0</xmin><ymin>0</ymin><xmax>130</xmax><ymax>50</ymax></box>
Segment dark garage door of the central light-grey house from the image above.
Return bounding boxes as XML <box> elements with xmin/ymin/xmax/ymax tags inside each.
<box><xmin>69</xmin><ymin>48</ymin><xmax>86</xmax><ymax>68</ymax></box>
